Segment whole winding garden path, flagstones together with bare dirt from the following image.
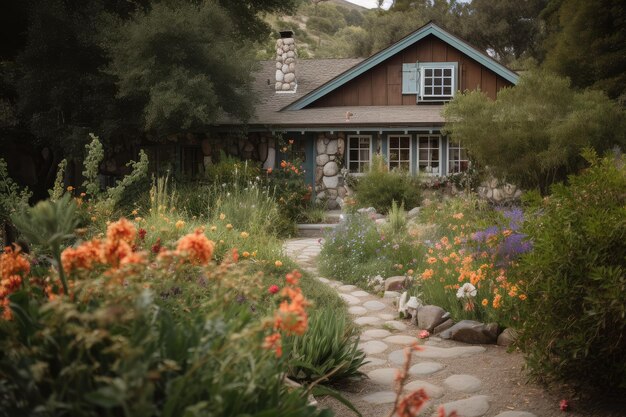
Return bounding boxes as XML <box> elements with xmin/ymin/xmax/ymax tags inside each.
<box><xmin>284</xmin><ymin>238</ymin><xmax>577</xmax><ymax>417</ymax></box>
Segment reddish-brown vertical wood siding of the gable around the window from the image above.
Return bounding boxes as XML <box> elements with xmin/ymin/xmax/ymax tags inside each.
<box><xmin>307</xmin><ymin>35</ymin><xmax>512</xmax><ymax>108</ymax></box>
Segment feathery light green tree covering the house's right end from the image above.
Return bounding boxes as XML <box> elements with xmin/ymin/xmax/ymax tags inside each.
<box><xmin>444</xmin><ymin>71</ymin><xmax>626</xmax><ymax>194</ymax></box>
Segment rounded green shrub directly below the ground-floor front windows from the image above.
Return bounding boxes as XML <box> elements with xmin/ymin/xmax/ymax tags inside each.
<box><xmin>356</xmin><ymin>155</ymin><xmax>421</xmax><ymax>213</ymax></box>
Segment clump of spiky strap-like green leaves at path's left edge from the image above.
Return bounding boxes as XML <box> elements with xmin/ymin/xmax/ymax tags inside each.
<box><xmin>286</xmin><ymin>309</ymin><xmax>365</xmax><ymax>384</ymax></box>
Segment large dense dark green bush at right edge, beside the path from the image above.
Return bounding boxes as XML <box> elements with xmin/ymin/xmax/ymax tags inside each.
<box><xmin>519</xmin><ymin>151</ymin><xmax>626</xmax><ymax>396</ymax></box>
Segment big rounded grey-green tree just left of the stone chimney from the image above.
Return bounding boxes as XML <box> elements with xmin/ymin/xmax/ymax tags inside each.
<box><xmin>106</xmin><ymin>1</ymin><xmax>253</xmax><ymax>133</ymax></box>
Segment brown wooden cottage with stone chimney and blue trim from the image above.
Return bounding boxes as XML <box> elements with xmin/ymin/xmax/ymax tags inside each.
<box><xmin>195</xmin><ymin>22</ymin><xmax>518</xmax><ymax>208</ymax></box>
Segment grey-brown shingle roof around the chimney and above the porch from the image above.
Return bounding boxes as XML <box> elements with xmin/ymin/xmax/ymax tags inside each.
<box><xmin>222</xmin><ymin>58</ymin><xmax>443</xmax><ymax>128</ymax></box>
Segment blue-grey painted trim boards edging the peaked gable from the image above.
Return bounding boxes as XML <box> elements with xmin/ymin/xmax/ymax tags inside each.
<box><xmin>282</xmin><ymin>22</ymin><xmax>519</xmax><ymax>110</ymax></box>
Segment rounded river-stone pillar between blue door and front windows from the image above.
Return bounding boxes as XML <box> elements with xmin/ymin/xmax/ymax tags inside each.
<box><xmin>315</xmin><ymin>133</ymin><xmax>347</xmax><ymax>210</ymax></box>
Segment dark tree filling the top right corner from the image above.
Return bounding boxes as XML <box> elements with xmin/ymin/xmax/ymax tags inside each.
<box><xmin>542</xmin><ymin>0</ymin><xmax>626</xmax><ymax>103</ymax></box>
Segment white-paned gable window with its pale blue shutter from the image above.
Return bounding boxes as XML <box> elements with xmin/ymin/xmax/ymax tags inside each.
<box><xmin>402</xmin><ymin>62</ymin><xmax>458</xmax><ymax>102</ymax></box>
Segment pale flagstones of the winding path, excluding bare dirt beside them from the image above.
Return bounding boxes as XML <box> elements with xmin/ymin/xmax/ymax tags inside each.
<box><xmin>285</xmin><ymin>238</ymin><xmax>536</xmax><ymax>417</ymax></box>
